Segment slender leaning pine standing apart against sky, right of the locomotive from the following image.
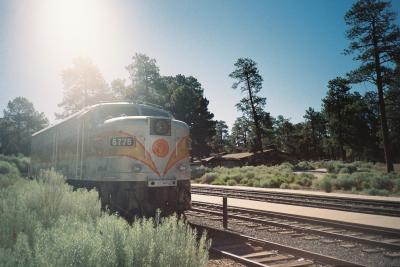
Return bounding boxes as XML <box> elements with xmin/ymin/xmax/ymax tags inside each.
<box><xmin>229</xmin><ymin>58</ymin><xmax>266</xmax><ymax>150</ymax></box>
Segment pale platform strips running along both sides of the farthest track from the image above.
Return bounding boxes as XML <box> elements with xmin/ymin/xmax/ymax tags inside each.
<box><xmin>192</xmin><ymin>184</ymin><xmax>400</xmax><ymax>230</ymax></box>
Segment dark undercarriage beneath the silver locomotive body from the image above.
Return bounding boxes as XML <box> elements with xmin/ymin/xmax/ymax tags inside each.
<box><xmin>67</xmin><ymin>180</ymin><xmax>191</xmax><ymax>221</ymax></box>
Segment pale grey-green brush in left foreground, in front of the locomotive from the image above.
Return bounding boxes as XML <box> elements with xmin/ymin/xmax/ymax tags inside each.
<box><xmin>0</xmin><ymin>171</ymin><xmax>210</xmax><ymax>266</ymax></box>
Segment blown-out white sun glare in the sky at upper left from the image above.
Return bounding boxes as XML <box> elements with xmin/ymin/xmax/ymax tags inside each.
<box><xmin>33</xmin><ymin>0</ymin><xmax>121</xmax><ymax>61</ymax></box>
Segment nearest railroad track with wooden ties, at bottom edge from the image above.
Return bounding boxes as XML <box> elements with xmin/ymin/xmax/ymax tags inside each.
<box><xmin>191</xmin><ymin>223</ymin><xmax>363</xmax><ymax>267</ymax></box>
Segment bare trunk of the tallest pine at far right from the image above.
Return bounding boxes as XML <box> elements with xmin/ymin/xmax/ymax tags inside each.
<box><xmin>372</xmin><ymin>25</ymin><xmax>394</xmax><ymax>172</ymax></box>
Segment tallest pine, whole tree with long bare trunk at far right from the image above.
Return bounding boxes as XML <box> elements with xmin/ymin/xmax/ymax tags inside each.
<box><xmin>345</xmin><ymin>0</ymin><xmax>400</xmax><ymax>172</ymax></box>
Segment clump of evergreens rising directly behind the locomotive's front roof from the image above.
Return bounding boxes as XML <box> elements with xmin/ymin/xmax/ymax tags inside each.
<box><xmin>111</xmin><ymin>53</ymin><xmax>219</xmax><ymax>156</ymax></box>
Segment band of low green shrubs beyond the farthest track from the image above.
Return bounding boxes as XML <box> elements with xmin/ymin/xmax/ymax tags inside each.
<box><xmin>195</xmin><ymin>161</ymin><xmax>400</xmax><ymax>194</ymax></box>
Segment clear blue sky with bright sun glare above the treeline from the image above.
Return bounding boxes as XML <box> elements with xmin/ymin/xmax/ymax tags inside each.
<box><xmin>0</xmin><ymin>0</ymin><xmax>400</xmax><ymax>126</ymax></box>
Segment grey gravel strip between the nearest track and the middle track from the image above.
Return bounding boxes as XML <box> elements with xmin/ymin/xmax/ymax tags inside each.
<box><xmin>187</xmin><ymin>215</ymin><xmax>400</xmax><ymax>266</ymax></box>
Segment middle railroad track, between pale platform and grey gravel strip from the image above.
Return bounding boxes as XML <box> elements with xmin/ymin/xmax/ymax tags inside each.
<box><xmin>187</xmin><ymin>202</ymin><xmax>400</xmax><ymax>253</ymax></box>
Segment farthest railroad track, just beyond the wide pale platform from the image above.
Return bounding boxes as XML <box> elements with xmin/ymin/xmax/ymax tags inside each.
<box><xmin>192</xmin><ymin>185</ymin><xmax>400</xmax><ymax>217</ymax></box>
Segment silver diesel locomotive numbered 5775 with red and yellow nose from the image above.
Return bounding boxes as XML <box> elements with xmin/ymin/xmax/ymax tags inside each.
<box><xmin>31</xmin><ymin>102</ymin><xmax>191</xmax><ymax>218</ymax></box>
